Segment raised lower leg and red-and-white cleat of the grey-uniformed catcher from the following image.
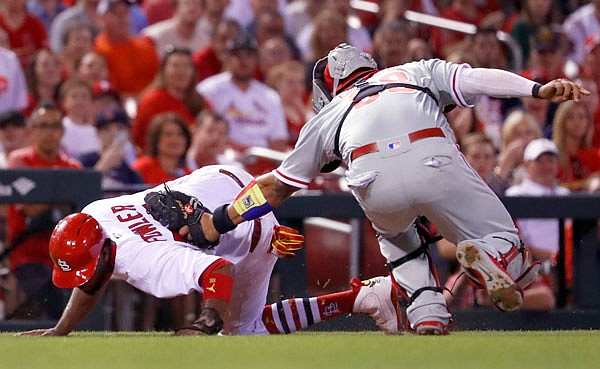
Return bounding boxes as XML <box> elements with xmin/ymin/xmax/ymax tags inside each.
<box><xmin>456</xmin><ymin>232</ymin><xmax>540</xmax><ymax>311</ymax></box>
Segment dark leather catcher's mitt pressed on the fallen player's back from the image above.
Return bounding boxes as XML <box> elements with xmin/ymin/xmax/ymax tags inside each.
<box><xmin>144</xmin><ymin>184</ymin><xmax>219</xmax><ymax>249</ymax></box>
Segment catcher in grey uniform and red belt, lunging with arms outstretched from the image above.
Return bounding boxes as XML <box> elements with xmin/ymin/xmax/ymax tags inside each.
<box><xmin>193</xmin><ymin>44</ymin><xmax>590</xmax><ymax>334</ymax></box>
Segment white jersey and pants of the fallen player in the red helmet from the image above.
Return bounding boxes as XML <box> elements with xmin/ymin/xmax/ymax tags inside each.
<box><xmin>82</xmin><ymin>166</ymin><xmax>277</xmax><ymax>334</ymax></box>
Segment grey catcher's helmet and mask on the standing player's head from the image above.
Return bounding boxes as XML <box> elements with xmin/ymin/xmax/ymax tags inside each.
<box><xmin>312</xmin><ymin>44</ymin><xmax>377</xmax><ymax>113</ymax></box>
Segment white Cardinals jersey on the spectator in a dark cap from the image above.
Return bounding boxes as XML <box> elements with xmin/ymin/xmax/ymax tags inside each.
<box><xmin>196</xmin><ymin>72</ymin><xmax>289</xmax><ymax>147</ymax></box>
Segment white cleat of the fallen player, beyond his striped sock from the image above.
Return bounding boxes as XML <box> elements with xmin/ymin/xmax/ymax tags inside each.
<box><xmin>350</xmin><ymin>276</ymin><xmax>402</xmax><ymax>334</ymax></box>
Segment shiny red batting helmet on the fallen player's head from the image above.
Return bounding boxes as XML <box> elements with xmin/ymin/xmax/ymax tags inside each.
<box><xmin>50</xmin><ymin>213</ymin><xmax>107</xmax><ymax>288</ymax></box>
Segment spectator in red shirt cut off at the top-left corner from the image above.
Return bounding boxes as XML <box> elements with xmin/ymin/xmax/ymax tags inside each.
<box><xmin>0</xmin><ymin>0</ymin><xmax>48</xmax><ymax>67</ymax></box>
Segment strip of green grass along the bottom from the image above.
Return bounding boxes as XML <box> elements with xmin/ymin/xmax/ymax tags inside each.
<box><xmin>0</xmin><ymin>331</ymin><xmax>600</xmax><ymax>369</ymax></box>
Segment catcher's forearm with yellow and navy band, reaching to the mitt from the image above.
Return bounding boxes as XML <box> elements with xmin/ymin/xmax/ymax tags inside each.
<box><xmin>200</xmin><ymin>173</ymin><xmax>300</xmax><ymax>241</ymax></box>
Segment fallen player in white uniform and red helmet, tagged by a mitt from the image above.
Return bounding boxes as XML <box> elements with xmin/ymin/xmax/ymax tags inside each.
<box><xmin>20</xmin><ymin>166</ymin><xmax>400</xmax><ymax>336</ymax></box>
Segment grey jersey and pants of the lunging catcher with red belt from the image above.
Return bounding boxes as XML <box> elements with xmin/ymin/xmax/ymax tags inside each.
<box><xmin>273</xmin><ymin>59</ymin><xmax>516</xmax><ymax>246</ymax></box>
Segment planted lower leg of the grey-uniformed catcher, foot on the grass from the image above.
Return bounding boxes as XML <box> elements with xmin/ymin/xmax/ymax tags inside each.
<box><xmin>379</xmin><ymin>221</ymin><xmax>451</xmax><ymax>334</ymax></box>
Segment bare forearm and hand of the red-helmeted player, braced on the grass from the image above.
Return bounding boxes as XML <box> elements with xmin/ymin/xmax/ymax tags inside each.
<box><xmin>17</xmin><ymin>283</ymin><xmax>107</xmax><ymax>336</ymax></box>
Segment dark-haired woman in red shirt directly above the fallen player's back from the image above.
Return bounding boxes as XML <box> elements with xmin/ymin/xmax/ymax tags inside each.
<box><xmin>131</xmin><ymin>113</ymin><xmax>192</xmax><ymax>185</ymax></box>
